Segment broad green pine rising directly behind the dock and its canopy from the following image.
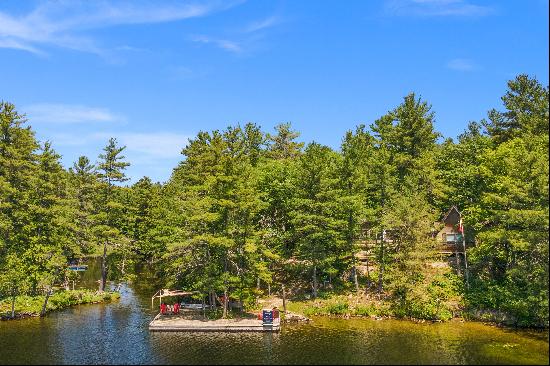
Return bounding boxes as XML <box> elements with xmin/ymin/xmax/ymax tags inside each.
<box><xmin>169</xmin><ymin>125</ymin><xmax>265</xmax><ymax>317</ymax></box>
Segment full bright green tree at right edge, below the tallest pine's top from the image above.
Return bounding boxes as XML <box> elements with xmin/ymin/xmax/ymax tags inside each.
<box><xmin>470</xmin><ymin>134</ymin><xmax>549</xmax><ymax>326</ymax></box>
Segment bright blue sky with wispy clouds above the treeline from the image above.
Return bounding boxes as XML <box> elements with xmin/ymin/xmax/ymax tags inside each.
<box><xmin>0</xmin><ymin>0</ymin><xmax>549</xmax><ymax>181</ymax></box>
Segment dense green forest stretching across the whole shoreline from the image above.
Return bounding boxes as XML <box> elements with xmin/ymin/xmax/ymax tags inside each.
<box><xmin>0</xmin><ymin>75</ymin><xmax>549</xmax><ymax>326</ymax></box>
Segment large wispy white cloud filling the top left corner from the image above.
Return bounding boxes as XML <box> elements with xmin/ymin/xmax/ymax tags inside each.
<box><xmin>0</xmin><ymin>0</ymin><xmax>240</xmax><ymax>55</ymax></box>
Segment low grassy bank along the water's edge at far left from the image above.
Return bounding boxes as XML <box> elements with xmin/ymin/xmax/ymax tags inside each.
<box><xmin>0</xmin><ymin>290</ymin><xmax>120</xmax><ymax>320</ymax></box>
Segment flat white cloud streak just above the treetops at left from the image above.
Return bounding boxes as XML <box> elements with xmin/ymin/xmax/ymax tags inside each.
<box><xmin>24</xmin><ymin>103</ymin><xmax>124</xmax><ymax>124</ymax></box>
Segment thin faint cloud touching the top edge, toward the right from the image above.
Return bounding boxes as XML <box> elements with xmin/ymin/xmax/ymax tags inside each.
<box><xmin>385</xmin><ymin>0</ymin><xmax>495</xmax><ymax>17</ymax></box>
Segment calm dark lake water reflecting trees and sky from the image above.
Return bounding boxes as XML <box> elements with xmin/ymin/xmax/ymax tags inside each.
<box><xmin>0</xmin><ymin>258</ymin><xmax>548</xmax><ymax>364</ymax></box>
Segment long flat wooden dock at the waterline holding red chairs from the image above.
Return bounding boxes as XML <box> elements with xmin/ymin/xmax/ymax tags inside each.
<box><xmin>149</xmin><ymin>314</ymin><xmax>281</xmax><ymax>332</ymax></box>
